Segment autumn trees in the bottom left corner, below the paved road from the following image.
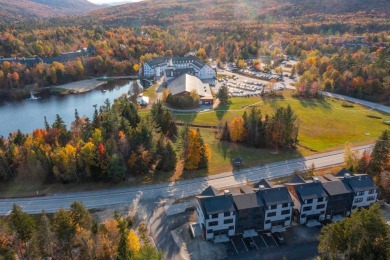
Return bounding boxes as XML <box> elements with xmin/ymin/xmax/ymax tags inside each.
<box><xmin>0</xmin><ymin>202</ymin><xmax>162</xmax><ymax>260</ymax></box>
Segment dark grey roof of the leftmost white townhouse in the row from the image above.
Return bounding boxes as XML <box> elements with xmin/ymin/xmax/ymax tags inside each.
<box><xmin>199</xmin><ymin>195</ymin><xmax>235</xmax><ymax>215</ymax></box>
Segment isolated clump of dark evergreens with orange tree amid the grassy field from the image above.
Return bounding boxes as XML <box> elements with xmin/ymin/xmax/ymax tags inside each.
<box><xmin>220</xmin><ymin>106</ymin><xmax>299</xmax><ymax>150</ymax></box>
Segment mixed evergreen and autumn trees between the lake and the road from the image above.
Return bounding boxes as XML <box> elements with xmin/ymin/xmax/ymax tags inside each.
<box><xmin>0</xmin><ymin>96</ymin><xmax>177</xmax><ymax>183</ymax></box>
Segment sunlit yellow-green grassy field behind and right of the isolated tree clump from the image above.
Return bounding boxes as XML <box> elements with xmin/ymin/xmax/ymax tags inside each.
<box><xmin>174</xmin><ymin>90</ymin><xmax>390</xmax><ymax>152</ymax></box>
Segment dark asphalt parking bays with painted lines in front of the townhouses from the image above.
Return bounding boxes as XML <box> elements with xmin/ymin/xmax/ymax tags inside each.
<box><xmin>224</xmin><ymin>234</ymin><xmax>283</xmax><ymax>257</ymax></box>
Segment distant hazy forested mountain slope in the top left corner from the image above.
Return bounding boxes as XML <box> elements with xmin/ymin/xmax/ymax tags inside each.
<box><xmin>0</xmin><ymin>0</ymin><xmax>101</xmax><ymax>21</ymax></box>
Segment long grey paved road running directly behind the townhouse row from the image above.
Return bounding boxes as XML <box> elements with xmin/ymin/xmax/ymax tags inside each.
<box><xmin>0</xmin><ymin>145</ymin><xmax>372</xmax><ymax>215</ymax></box>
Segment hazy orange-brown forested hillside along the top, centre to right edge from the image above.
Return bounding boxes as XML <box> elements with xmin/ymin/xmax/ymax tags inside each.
<box><xmin>87</xmin><ymin>0</ymin><xmax>390</xmax><ymax>32</ymax></box>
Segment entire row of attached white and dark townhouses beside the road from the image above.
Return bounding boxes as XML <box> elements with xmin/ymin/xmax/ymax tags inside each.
<box><xmin>196</xmin><ymin>170</ymin><xmax>378</xmax><ymax>242</ymax></box>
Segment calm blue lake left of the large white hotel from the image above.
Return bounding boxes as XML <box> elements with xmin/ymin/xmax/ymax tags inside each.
<box><xmin>0</xmin><ymin>81</ymin><xmax>132</xmax><ymax>137</ymax></box>
